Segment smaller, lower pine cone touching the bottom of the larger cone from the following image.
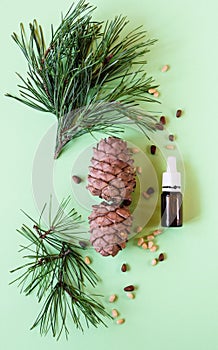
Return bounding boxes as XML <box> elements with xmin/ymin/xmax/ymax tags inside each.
<box><xmin>89</xmin><ymin>202</ymin><xmax>132</xmax><ymax>256</ymax></box>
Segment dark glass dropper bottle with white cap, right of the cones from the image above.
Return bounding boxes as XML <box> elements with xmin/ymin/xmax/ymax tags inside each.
<box><xmin>161</xmin><ymin>157</ymin><xmax>182</xmax><ymax>227</ymax></box>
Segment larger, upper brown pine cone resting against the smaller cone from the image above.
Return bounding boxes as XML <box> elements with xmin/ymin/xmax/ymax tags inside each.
<box><xmin>87</xmin><ymin>137</ymin><xmax>136</xmax><ymax>205</ymax></box>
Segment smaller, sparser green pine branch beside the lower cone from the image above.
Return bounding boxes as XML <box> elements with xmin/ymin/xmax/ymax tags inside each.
<box><xmin>11</xmin><ymin>198</ymin><xmax>110</xmax><ymax>339</ymax></box>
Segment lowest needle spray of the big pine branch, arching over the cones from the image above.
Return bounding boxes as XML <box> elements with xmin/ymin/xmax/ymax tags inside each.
<box><xmin>55</xmin><ymin>102</ymin><xmax>157</xmax><ymax>158</ymax></box>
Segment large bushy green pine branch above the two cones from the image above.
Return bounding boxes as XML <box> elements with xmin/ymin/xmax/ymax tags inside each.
<box><xmin>7</xmin><ymin>0</ymin><xmax>156</xmax><ymax>157</ymax></box>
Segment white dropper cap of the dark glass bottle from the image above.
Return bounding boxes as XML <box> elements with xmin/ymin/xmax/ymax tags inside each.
<box><xmin>162</xmin><ymin>157</ymin><xmax>181</xmax><ymax>192</ymax></box>
